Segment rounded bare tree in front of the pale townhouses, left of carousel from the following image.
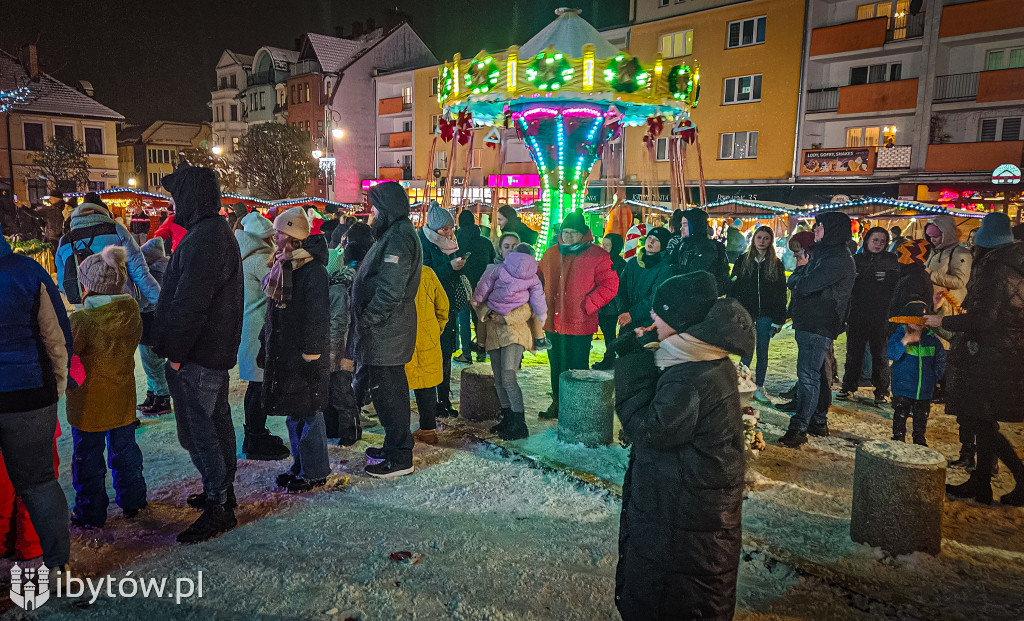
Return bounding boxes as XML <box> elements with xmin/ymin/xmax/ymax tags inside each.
<box><xmin>234</xmin><ymin>123</ymin><xmax>319</xmax><ymax>199</ymax></box>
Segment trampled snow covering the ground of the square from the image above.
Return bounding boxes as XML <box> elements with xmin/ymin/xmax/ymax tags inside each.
<box><xmin>0</xmin><ymin>333</ymin><xmax>1024</xmax><ymax>621</ymax></box>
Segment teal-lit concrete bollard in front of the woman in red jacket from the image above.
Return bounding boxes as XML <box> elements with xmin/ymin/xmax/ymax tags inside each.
<box><xmin>558</xmin><ymin>370</ymin><xmax>615</xmax><ymax>447</ymax></box>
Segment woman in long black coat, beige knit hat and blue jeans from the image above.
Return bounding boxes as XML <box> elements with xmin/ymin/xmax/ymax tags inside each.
<box><xmin>257</xmin><ymin>207</ymin><xmax>331</xmax><ymax>492</ymax></box>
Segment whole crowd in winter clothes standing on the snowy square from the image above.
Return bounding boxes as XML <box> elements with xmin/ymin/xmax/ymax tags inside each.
<box><xmin>0</xmin><ymin>165</ymin><xmax>1024</xmax><ymax>619</ymax></box>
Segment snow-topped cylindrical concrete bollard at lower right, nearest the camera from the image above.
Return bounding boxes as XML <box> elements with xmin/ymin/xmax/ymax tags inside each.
<box><xmin>850</xmin><ymin>441</ymin><xmax>946</xmax><ymax>554</ymax></box>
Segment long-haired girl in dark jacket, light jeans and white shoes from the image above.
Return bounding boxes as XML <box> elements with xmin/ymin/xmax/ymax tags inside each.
<box><xmin>728</xmin><ymin>226</ymin><xmax>786</xmax><ymax>404</ymax></box>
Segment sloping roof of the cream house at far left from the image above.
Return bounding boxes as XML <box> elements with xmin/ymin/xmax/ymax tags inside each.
<box><xmin>0</xmin><ymin>50</ymin><xmax>124</xmax><ymax>121</ymax></box>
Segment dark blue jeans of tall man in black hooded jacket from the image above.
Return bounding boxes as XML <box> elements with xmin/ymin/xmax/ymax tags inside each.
<box><xmin>167</xmin><ymin>362</ymin><xmax>237</xmax><ymax>504</ymax></box>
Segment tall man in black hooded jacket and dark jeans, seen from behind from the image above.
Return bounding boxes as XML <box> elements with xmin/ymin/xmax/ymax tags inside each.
<box><xmin>154</xmin><ymin>164</ymin><xmax>244</xmax><ymax>543</ymax></box>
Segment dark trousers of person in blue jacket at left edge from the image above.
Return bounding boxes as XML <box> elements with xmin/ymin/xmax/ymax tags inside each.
<box><xmin>0</xmin><ymin>403</ymin><xmax>71</xmax><ymax>567</ymax></box>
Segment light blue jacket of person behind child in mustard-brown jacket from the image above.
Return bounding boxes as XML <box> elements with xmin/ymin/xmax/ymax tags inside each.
<box><xmin>56</xmin><ymin>203</ymin><xmax>160</xmax><ymax>308</ymax></box>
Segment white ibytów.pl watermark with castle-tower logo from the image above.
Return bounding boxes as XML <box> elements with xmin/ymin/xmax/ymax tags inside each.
<box><xmin>10</xmin><ymin>563</ymin><xmax>203</xmax><ymax>611</ymax></box>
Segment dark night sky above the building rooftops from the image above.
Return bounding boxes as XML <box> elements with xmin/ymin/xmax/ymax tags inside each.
<box><xmin>0</xmin><ymin>0</ymin><xmax>629</xmax><ymax>123</ymax></box>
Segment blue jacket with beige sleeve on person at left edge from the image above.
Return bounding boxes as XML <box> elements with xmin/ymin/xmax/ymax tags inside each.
<box><xmin>0</xmin><ymin>225</ymin><xmax>72</xmax><ymax>412</ymax></box>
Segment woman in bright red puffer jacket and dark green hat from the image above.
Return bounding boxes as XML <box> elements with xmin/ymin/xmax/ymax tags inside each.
<box><xmin>539</xmin><ymin>212</ymin><xmax>618</xmax><ymax>419</ymax></box>
